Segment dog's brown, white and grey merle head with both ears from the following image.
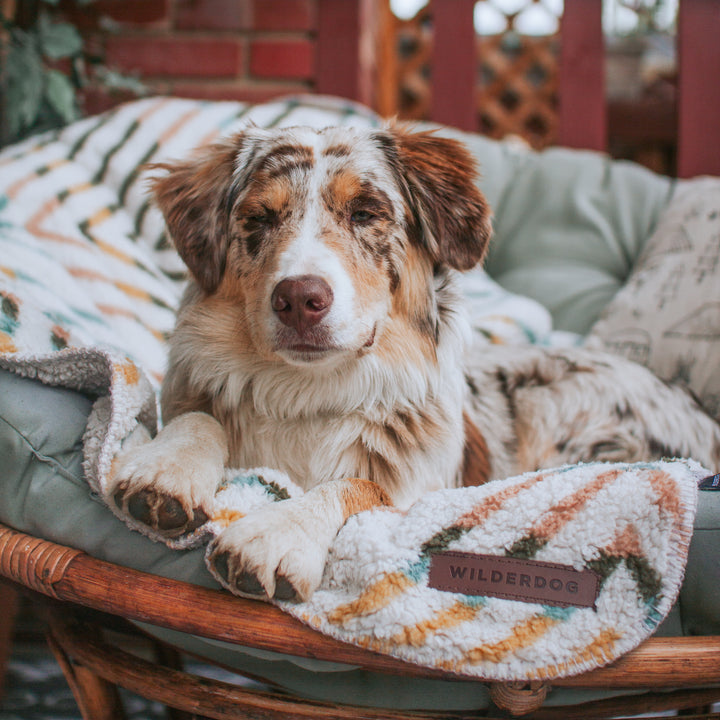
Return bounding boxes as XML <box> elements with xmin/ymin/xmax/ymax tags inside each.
<box><xmin>153</xmin><ymin>127</ymin><xmax>490</xmax><ymax>365</ymax></box>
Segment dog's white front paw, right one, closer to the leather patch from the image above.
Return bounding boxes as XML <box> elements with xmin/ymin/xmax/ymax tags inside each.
<box><xmin>208</xmin><ymin>498</ymin><xmax>337</xmax><ymax>601</ymax></box>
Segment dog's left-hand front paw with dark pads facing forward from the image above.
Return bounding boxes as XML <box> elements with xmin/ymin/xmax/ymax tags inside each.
<box><xmin>107</xmin><ymin>413</ymin><xmax>227</xmax><ymax>538</ymax></box>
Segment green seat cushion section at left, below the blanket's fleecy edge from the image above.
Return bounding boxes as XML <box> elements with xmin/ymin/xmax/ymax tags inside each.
<box><xmin>0</xmin><ymin>370</ymin><xmax>218</xmax><ymax>587</ymax></box>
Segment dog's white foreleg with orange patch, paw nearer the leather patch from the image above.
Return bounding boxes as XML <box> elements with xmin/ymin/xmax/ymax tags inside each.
<box><xmin>208</xmin><ymin>479</ymin><xmax>392</xmax><ymax>600</ymax></box>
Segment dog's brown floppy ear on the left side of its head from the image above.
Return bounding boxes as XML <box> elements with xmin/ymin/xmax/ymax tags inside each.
<box><xmin>151</xmin><ymin>134</ymin><xmax>242</xmax><ymax>293</ymax></box>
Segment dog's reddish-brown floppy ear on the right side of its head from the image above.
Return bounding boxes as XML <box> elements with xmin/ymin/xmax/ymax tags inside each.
<box><xmin>389</xmin><ymin>127</ymin><xmax>492</xmax><ymax>270</ymax></box>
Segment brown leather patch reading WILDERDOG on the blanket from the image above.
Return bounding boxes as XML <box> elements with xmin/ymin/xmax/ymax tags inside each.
<box><xmin>428</xmin><ymin>551</ymin><xmax>600</xmax><ymax>608</ymax></box>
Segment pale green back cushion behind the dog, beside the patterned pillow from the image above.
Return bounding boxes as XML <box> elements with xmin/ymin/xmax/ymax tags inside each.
<box><xmin>422</xmin><ymin>124</ymin><xmax>673</xmax><ymax>335</ymax></box>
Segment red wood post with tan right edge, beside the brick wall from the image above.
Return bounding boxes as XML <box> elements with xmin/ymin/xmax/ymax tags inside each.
<box><xmin>315</xmin><ymin>0</ymin><xmax>377</xmax><ymax>105</ymax></box>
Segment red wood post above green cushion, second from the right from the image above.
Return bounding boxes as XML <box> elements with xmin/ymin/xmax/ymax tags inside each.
<box><xmin>558</xmin><ymin>0</ymin><xmax>607</xmax><ymax>150</ymax></box>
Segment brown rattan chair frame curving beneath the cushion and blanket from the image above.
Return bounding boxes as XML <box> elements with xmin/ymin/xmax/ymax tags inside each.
<box><xmin>0</xmin><ymin>526</ymin><xmax>720</xmax><ymax>720</ymax></box>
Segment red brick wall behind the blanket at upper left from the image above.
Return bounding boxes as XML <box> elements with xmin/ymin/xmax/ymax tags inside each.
<box><xmin>73</xmin><ymin>0</ymin><xmax>324</xmax><ymax>111</ymax></box>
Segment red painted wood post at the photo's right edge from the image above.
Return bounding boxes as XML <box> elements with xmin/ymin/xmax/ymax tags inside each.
<box><xmin>677</xmin><ymin>0</ymin><xmax>720</xmax><ymax>177</ymax></box>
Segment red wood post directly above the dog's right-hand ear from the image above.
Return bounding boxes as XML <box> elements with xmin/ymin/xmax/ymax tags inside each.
<box><xmin>430</xmin><ymin>0</ymin><xmax>478</xmax><ymax>130</ymax></box>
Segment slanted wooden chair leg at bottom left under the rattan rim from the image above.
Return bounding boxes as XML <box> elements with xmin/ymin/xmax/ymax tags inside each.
<box><xmin>47</xmin><ymin>628</ymin><xmax>125</xmax><ymax>720</ymax></box>
